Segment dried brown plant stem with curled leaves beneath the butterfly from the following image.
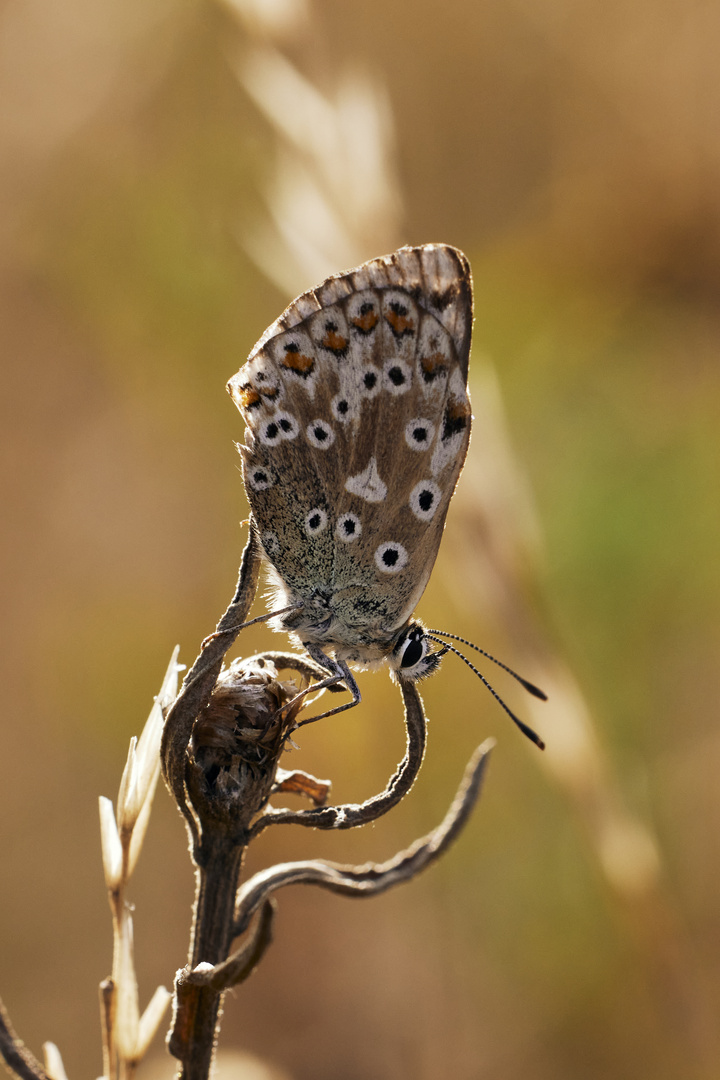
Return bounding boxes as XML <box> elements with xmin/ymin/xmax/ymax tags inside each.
<box><xmin>158</xmin><ymin>538</ymin><xmax>496</xmax><ymax>1080</ymax></box>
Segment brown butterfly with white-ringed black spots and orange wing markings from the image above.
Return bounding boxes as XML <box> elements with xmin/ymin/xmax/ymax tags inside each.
<box><xmin>228</xmin><ymin>244</ymin><xmax>544</xmax><ymax>743</ymax></box>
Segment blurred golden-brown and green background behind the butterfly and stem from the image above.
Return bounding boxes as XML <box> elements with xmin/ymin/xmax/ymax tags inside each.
<box><xmin>0</xmin><ymin>0</ymin><xmax>720</xmax><ymax>1080</ymax></box>
